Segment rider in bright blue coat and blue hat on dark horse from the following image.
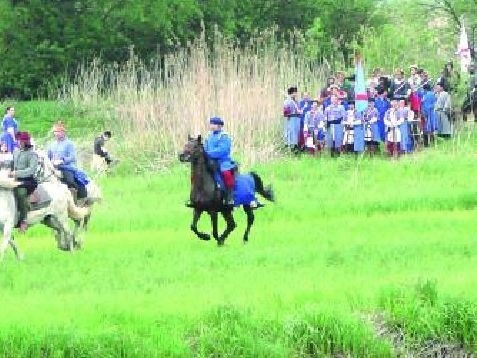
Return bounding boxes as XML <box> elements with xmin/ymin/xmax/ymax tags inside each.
<box><xmin>204</xmin><ymin>117</ymin><xmax>236</xmax><ymax>208</ymax></box>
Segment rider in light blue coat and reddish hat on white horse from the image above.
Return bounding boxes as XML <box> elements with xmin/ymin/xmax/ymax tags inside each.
<box><xmin>48</xmin><ymin>121</ymin><xmax>88</xmax><ymax>202</ymax></box>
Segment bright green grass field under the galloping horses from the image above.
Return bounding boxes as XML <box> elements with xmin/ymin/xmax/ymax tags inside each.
<box><xmin>0</xmin><ymin>125</ymin><xmax>477</xmax><ymax>357</ymax></box>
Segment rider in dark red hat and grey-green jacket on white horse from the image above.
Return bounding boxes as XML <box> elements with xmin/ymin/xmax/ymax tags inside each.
<box><xmin>10</xmin><ymin>132</ymin><xmax>38</xmax><ymax>232</ymax></box>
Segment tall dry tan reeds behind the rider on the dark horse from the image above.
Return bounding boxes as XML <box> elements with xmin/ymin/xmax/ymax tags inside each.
<box><xmin>60</xmin><ymin>32</ymin><xmax>327</xmax><ymax>167</ymax></box>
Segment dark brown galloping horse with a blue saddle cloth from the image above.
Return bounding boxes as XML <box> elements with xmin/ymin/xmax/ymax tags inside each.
<box><xmin>179</xmin><ymin>135</ymin><xmax>274</xmax><ymax>246</ymax></box>
